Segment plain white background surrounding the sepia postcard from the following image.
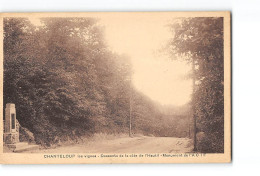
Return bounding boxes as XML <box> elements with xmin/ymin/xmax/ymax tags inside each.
<box><xmin>0</xmin><ymin>0</ymin><xmax>260</xmax><ymax>176</ymax></box>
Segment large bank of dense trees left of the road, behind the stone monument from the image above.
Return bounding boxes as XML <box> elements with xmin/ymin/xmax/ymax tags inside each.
<box><xmin>4</xmin><ymin>18</ymin><xmax>187</xmax><ymax>146</ymax></box>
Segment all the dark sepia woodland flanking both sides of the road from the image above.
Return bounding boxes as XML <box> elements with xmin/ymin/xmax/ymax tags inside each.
<box><xmin>3</xmin><ymin>18</ymin><xmax>224</xmax><ymax>153</ymax></box>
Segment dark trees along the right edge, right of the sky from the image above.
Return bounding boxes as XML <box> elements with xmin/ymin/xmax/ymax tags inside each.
<box><xmin>168</xmin><ymin>18</ymin><xmax>224</xmax><ymax>152</ymax></box>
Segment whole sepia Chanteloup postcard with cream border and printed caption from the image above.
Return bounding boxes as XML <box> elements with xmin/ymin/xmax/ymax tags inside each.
<box><xmin>0</xmin><ymin>12</ymin><xmax>231</xmax><ymax>164</ymax></box>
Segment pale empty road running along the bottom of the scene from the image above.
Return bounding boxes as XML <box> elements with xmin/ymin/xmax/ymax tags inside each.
<box><xmin>35</xmin><ymin>136</ymin><xmax>192</xmax><ymax>153</ymax></box>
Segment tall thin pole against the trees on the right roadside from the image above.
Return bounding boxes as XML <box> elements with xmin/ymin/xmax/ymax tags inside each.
<box><xmin>192</xmin><ymin>58</ymin><xmax>197</xmax><ymax>152</ymax></box>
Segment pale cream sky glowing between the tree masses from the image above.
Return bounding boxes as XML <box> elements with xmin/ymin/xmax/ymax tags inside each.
<box><xmin>96</xmin><ymin>14</ymin><xmax>192</xmax><ymax>106</ymax></box>
